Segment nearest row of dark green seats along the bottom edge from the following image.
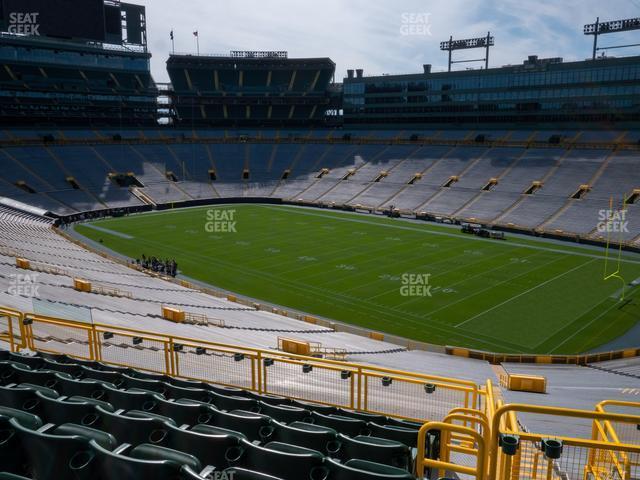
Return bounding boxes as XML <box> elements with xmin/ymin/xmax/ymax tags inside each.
<box><xmin>0</xmin><ymin>411</ymin><xmax>414</xmax><ymax>480</ymax></box>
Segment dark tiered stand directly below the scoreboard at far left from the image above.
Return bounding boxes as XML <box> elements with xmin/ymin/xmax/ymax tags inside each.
<box><xmin>0</xmin><ymin>36</ymin><xmax>158</xmax><ymax>126</ymax></box>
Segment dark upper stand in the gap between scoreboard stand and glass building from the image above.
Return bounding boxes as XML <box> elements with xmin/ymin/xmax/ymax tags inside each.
<box><xmin>167</xmin><ymin>52</ymin><xmax>340</xmax><ymax>126</ymax></box>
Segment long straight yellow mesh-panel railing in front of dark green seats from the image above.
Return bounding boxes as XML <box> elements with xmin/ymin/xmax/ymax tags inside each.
<box><xmin>0</xmin><ymin>309</ymin><xmax>478</xmax><ymax>422</ymax></box>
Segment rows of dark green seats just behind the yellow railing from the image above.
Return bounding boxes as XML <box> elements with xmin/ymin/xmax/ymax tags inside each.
<box><xmin>0</xmin><ymin>352</ymin><xmax>420</xmax><ymax>480</ymax></box>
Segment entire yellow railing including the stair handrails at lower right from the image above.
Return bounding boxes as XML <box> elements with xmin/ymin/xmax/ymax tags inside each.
<box><xmin>0</xmin><ymin>308</ymin><xmax>640</xmax><ymax>480</ymax></box>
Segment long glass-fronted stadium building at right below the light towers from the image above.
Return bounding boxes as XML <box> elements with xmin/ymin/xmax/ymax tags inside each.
<box><xmin>343</xmin><ymin>56</ymin><xmax>640</xmax><ymax>126</ymax></box>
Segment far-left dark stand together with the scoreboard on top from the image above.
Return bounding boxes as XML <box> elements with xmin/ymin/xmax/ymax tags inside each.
<box><xmin>0</xmin><ymin>0</ymin><xmax>158</xmax><ymax>126</ymax></box>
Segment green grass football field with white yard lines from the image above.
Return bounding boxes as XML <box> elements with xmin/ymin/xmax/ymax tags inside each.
<box><xmin>76</xmin><ymin>205</ymin><xmax>640</xmax><ymax>354</ymax></box>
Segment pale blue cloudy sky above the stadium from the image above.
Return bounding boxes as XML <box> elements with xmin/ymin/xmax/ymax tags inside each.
<box><xmin>134</xmin><ymin>0</ymin><xmax>640</xmax><ymax>82</ymax></box>
